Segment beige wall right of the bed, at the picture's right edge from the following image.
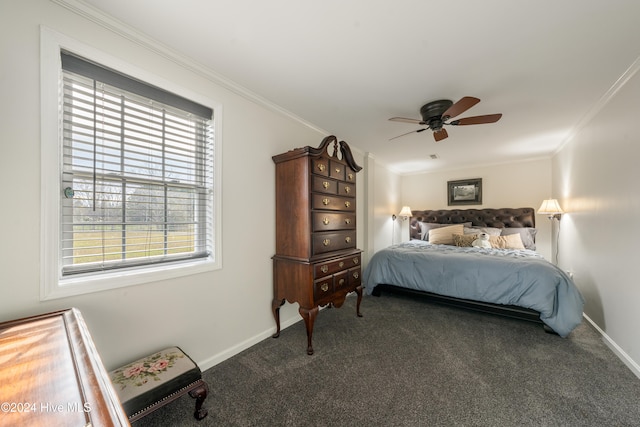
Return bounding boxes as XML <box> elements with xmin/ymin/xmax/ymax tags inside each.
<box><xmin>553</xmin><ymin>61</ymin><xmax>640</xmax><ymax>376</ymax></box>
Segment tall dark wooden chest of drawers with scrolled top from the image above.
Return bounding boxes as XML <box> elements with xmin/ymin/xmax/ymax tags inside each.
<box><xmin>272</xmin><ymin>136</ymin><xmax>362</xmax><ymax>354</ymax></box>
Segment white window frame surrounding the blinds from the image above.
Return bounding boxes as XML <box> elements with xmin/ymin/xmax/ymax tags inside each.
<box><xmin>40</xmin><ymin>27</ymin><xmax>222</xmax><ymax>300</ymax></box>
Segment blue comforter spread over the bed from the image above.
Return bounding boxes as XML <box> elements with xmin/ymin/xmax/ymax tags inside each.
<box><xmin>363</xmin><ymin>240</ymin><xmax>584</xmax><ymax>337</ymax></box>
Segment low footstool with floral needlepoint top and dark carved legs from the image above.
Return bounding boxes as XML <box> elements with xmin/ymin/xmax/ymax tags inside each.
<box><xmin>109</xmin><ymin>347</ymin><xmax>209</xmax><ymax>422</ymax></box>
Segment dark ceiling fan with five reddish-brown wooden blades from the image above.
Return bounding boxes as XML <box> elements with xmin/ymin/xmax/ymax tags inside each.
<box><xmin>389</xmin><ymin>96</ymin><xmax>502</xmax><ymax>142</ymax></box>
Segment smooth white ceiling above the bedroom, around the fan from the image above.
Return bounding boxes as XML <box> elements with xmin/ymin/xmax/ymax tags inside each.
<box><xmin>80</xmin><ymin>0</ymin><xmax>640</xmax><ymax>173</ymax></box>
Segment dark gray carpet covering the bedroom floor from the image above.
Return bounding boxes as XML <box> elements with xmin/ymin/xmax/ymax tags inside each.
<box><xmin>134</xmin><ymin>294</ymin><xmax>640</xmax><ymax>427</ymax></box>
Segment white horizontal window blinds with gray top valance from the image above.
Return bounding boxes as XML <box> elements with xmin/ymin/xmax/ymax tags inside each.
<box><xmin>60</xmin><ymin>52</ymin><xmax>214</xmax><ymax>276</ymax></box>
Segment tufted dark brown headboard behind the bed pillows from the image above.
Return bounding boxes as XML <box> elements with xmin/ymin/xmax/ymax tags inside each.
<box><xmin>409</xmin><ymin>208</ymin><xmax>536</xmax><ymax>239</ymax></box>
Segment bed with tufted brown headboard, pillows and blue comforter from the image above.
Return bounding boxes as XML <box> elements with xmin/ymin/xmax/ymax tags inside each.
<box><xmin>363</xmin><ymin>208</ymin><xmax>584</xmax><ymax>337</ymax></box>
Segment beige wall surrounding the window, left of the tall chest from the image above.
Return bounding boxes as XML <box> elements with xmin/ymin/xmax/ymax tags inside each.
<box><xmin>0</xmin><ymin>0</ymin><xmax>362</xmax><ymax>368</ymax></box>
